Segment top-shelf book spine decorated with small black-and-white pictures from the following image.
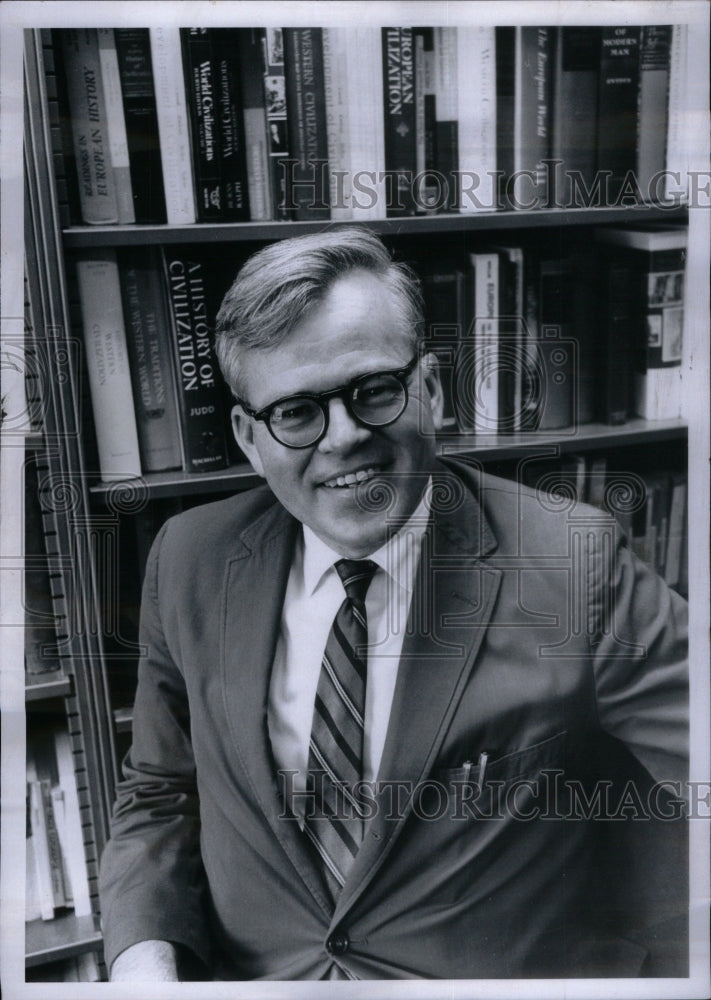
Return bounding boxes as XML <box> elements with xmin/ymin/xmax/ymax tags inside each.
<box><xmin>261</xmin><ymin>28</ymin><xmax>293</xmax><ymax>221</ymax></box>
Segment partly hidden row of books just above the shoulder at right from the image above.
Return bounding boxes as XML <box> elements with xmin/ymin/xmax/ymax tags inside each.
<box><xmin>522</xmin><ymin>454</ymin><xmax>688</xmax><ymax>594</ymax></box>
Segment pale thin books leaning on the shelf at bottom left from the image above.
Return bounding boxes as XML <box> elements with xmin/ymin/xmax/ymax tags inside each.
<box><xmin>25</xmin><ymin>729</ymin><xmax>92</xmax><ymax>921</ymax></box>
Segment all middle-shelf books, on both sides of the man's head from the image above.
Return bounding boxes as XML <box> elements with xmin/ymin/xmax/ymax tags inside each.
<box><xmin>77</xmin><ymin>226</ymin><xmax>687</xmax><ymax>481</ymax></box>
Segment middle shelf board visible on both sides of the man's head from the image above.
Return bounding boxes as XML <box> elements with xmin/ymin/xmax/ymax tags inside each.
<box><xmin>90</xmin><ymin>418</ymin><xmax>687</xmax><ymax>504</ymax></box>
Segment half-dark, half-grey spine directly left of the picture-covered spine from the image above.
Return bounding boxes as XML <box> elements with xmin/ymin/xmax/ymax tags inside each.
<box><xmin>238</xmin><ymin>28</ymin><xmax>274</xmax><ymax>222</ymax></box>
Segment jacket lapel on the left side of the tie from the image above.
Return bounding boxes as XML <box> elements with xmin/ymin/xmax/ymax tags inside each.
<box><xmin>221</xmin><ymin>504</ymin><xmax>331</xmax><ymax>914</ymax></box>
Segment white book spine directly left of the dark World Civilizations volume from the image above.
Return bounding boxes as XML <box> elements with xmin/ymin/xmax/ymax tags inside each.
<box><xmin>149</xmin><ymin>26</ymin><xmax>196</xmax><ymax>226</ymax></box>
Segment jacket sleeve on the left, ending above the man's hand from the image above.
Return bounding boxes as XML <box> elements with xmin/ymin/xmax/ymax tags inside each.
<box><xmin>100</xmin><ymin>525</ymin><xmax>209</xmax><ymax>968</ymax></box>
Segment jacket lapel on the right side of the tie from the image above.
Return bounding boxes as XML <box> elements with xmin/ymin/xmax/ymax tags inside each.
<box><xmin>333</xmin><ymin>472</ymin><xmax>501</xmax><ymax>924</ymax></box>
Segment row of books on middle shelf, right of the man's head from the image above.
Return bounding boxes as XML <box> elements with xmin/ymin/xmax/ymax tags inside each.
<box><xmin>423</xmin><ymin>226</ymin><xmax>687</xmax><ymax>435</ymax></box>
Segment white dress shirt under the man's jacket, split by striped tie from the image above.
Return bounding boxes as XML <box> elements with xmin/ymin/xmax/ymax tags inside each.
<box><xmin>267</xmin><ymin>488</ymin><xmax>430</xmax><ymax>805</ymax></box>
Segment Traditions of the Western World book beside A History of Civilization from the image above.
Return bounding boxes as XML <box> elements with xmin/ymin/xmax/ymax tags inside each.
<box><xmin>118</xmin><ymin>247</ymin><xmax>182</xmax><ymax>473</ymax></box>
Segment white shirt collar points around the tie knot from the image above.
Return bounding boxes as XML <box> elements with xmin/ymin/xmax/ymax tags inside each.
<box><xmin>302</xmin><ymin>477</ymin><xmax>432</xmax><ymax>594</ymax></box>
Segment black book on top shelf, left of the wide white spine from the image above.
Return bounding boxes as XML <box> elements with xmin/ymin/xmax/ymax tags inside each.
<box><xmin>115</xmin><ymin>28</ymin><xmax>166</xmax><ymax>225</ymax></box>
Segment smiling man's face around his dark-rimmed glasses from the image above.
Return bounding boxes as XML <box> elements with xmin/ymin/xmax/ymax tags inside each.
<box><xmin>233</xmin><ymin>270</ymin><xmax>442</xmax><ymax>559</ymax></box>
